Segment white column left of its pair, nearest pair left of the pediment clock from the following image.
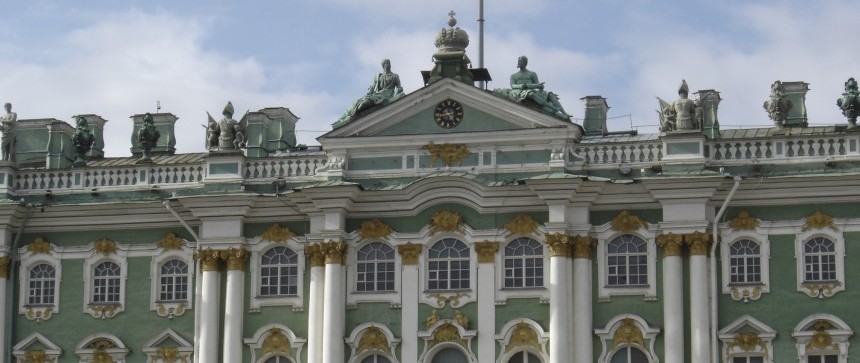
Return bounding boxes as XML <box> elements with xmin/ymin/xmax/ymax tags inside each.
<box><xmin>305</xmin><ymin>244</ymin><xmax>325</xmax><ymax>362</ymax></box>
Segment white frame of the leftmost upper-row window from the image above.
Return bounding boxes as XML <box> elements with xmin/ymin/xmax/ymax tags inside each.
<box><xmin>18</xmin><ymin>247</ymin><xmax>63</xmax><ymax>321</ymax></box>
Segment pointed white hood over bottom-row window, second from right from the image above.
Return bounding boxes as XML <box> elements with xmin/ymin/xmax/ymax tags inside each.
<box><xmin>717</xmin><ymin>315</ymin><xmax>776</xmax><ymax>363</ymax></box>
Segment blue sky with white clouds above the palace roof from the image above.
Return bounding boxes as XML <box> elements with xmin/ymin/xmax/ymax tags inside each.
<box><xmin>0</xmin><ymin>0</ymin><xmax>860</xmax><ymax>157</ymax></box>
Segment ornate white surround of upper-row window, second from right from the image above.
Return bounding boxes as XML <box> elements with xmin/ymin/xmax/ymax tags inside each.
<box><xmin>720</xmin><ymin>226</ymin><xmax>770</xmax><ymax>302</ymax></box>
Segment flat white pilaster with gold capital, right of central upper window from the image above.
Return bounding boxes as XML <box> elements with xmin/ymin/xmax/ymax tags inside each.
<box><xmin>474</xmin><ymin>242</ymin><xmax>499</xmax><ymax>362</ymax></box>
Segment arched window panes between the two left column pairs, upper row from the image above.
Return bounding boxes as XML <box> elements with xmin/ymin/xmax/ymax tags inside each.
<box><xmin>260</xmin><ymin>246</ymin><xmax>299</xmax><ymax>296</ymax></box>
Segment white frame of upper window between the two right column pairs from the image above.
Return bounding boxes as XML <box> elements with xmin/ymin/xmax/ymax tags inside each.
<box><xmin>596</xmin><ymin>223</ymin><xmax>657</xmax><ymax>302</ymax></box>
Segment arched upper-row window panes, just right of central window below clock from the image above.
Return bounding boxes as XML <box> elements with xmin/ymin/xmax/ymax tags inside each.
<box><xmin>504</xmin><ymin>237</ymin><xmax>543</xmax><ymax>288</ymax></box>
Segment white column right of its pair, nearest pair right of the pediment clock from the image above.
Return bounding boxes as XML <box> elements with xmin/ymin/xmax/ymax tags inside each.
<box><xmin>571</xmin><ymin>236</ymin><xmax>594</xmax><ymax>363</ymax></box>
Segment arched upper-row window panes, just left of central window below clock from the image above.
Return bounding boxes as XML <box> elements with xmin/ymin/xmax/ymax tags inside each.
<box><xmin>356</xmin><ymin>242</ymin><xmax>394</xmax><ymax>292</ymax></box>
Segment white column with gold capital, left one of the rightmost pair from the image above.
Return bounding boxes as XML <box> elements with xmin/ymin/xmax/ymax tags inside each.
<box><xmin>657</xmin><ymin>234</ymin><xmax>684</xmax><ymax>363</ymax></box>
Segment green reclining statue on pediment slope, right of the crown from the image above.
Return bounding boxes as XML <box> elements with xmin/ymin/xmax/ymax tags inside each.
<box><xmin>493</xmin><ymin>56</ymin><xmax>570</xmax><ymax>118</ymax></box>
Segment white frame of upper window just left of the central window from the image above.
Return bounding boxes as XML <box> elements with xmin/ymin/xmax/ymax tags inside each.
<box><xmin>346</xmin><ymin>240</ymin><xmax>403</xmax><ymax>306</ymax></box>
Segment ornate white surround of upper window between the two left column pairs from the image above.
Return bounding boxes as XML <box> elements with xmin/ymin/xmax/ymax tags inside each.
<box><xmin>247</xmin><ymin>237</ymin><xmax>305</xmax><ymax>312</ymax></box>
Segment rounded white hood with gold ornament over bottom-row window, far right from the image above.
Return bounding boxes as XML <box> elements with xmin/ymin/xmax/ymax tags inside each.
<box><xmin>791</xmin><ymin>314</ymin><xmax>854</xmax><ymax>363</ymax></box>
